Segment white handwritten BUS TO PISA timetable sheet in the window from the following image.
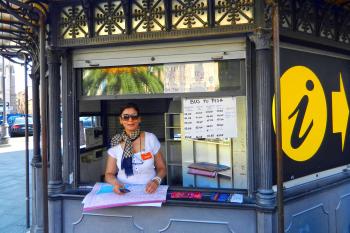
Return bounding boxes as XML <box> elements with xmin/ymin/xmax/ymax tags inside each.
<box><xmin>183</xmin><ymin>97</ymin><xmax>237</xmax><ymax>139</ymax></box>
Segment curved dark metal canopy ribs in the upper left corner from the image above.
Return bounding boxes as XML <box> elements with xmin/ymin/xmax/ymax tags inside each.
<box><xmin>0</xmin><ymin>0</ymin><xmax>350</xmax><ymax>59</ymax></box>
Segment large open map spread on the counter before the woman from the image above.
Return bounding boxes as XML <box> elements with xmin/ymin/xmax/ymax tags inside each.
<box><xmin>82</xmin><ymin>183</ymin><xmax>168</xmax><ymax>211</ymax></box>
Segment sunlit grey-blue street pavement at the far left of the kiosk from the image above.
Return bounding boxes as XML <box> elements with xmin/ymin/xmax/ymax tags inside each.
<box><xmin>0</xmin><ymin>137</ymin><xmax>33</xmax><ymax>233</ymax></box>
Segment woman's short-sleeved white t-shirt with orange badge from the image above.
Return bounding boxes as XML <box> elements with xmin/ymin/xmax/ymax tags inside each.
<box><xmin>108</xmin><ymin>132</ymin><xmax>160</xmax><ymax>184</ymax></box>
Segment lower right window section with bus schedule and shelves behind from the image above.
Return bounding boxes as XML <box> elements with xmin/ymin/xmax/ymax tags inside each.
<box><xmin>164</xmin><ymin>96</ymin><xmax>247</xmax><ymax>189</ymax></box>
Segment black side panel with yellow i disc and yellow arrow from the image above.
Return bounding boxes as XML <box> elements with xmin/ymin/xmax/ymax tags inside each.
<box><xmin>272</xmin><ymin>48</ymin><xmax>350</xmax><ymax>182</ymax></box>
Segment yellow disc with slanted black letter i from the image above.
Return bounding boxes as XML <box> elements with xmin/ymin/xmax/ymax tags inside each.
<box><xmin>272</xmin><ymin>66</ymin><xmax>327</xmax><ymax>162</ymax></box>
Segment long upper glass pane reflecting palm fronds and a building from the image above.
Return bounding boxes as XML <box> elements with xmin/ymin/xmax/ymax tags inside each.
<box><xmin>82</xmin><ymin>60</ymin><xmax>241</xmax><ymax>96</ymax></box>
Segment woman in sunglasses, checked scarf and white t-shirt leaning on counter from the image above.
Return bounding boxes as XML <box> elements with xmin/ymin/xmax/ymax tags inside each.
<box><xmin>105</xmin><ymin>103</ymin><xmax>166</xmax><ymax>194</ymax></box>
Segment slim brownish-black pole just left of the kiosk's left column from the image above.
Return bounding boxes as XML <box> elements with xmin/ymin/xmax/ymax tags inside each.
<box><xmin>39</xmin><ymin>14</ymin><xmax>49</xmax><ymax>233</ymax></box>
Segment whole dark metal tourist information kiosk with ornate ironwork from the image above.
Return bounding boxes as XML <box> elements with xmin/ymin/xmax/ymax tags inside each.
<box><xmin>0</xmin><ymin>0</ymin><xmax>350</xmax><ymax>233</ymax></box>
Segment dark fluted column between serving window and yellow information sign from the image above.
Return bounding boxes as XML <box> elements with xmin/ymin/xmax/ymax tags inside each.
<box><xmin>250</xmin><ymin>28</ymin><xmax>276</xmax><ymax>208</ymax></box>
